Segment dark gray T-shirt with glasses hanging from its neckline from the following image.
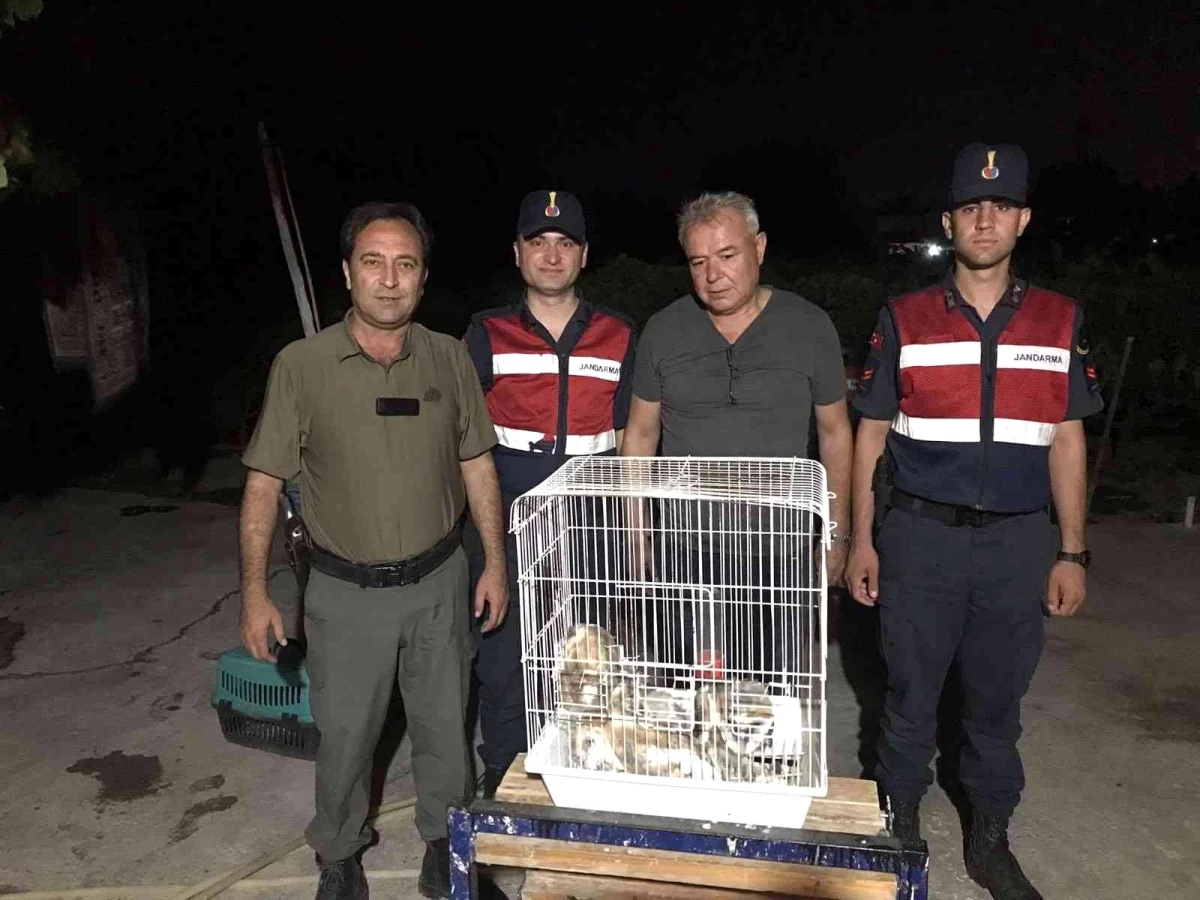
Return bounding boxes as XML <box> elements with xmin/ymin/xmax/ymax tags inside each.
<box><xmin>634</xmin><ymin>288</ymin><xmax>846</xmax><ymax>457</ymax></box>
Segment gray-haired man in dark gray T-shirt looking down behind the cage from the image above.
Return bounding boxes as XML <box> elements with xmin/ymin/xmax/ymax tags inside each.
<box><xmin>620</xmin><ymin>192</ymin><xmax>853</xmax><ymax>676</ymax></box>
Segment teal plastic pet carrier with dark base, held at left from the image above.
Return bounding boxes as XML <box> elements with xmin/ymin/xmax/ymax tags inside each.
<box><xmin>212</xmin><ymin>640</ymin><xmax>320</xmax><ymax>760</ymax></box>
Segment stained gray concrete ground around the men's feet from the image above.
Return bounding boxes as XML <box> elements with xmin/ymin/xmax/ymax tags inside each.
<box><xmin>0</xmin><ymin>460</ymin><xmax>1200</xmax><ymax>900</ymax></box>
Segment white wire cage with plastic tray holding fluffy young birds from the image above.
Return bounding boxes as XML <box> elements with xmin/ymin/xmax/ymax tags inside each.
<box><xmin>512</xmin><ymin>456</ymin><xmax>833</xmax><ymax>828</ymax></box>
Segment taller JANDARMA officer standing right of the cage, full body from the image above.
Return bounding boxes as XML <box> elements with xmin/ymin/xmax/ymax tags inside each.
<box><xmin>846</xmin><ymin>144</ymin><xmax>1103</xmax><ymax>900</ymax></box>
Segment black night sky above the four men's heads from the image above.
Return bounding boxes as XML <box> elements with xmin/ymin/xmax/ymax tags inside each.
<box><xmin>0</xmin><ymin>0</ymin><xmax>1200</xmax><ymax>285</ymax></box>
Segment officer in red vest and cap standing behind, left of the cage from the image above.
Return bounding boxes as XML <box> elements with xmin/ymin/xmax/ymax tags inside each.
<box><xmin>463</xmin><ymin>191</ymin><xmax>637</xmax><ymax>797</ymax></box>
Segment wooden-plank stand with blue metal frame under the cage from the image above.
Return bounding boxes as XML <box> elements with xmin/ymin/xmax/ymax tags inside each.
<box><xmin>451</xmin><ymin>756</ymin><xmax>928</xmax><ymax>900</ymax></box>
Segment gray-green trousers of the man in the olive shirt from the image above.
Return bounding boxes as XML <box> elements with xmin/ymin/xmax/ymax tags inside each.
<box><xmin>305</xmin><ymin>547</ymin><xmax>470</xmax><ymax>860</ymax></box>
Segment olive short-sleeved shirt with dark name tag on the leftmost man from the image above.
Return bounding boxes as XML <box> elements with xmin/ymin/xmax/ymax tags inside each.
<box><xmin>241</xmin><ymin>316</ymin><xmax>496</xmax><ymax>563</ymax></box>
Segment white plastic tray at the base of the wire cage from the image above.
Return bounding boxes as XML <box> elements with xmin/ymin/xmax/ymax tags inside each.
<box><xmin>526</xmin><ymin>722</ymin><xmax>828</xmax><ymax>828</ymax></box>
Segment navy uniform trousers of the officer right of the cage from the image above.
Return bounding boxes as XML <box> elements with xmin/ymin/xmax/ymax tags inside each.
<box><xmin>876</xmin><ymin>509</ymin><xmax>1056</xmax><ymax>815</ymax></box>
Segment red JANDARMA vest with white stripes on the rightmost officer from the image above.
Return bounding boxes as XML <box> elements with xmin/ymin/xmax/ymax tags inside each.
<box><xmin>889</xmin><ymin>287</ymin><xmax>1076</xmax><ymax>511</ymax></box>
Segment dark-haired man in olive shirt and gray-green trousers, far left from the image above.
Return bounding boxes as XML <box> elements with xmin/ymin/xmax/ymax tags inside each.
<box><xmin>241</xmin><ymin>203</ymin><xmax>508</xmax><ymax>900</ymax></box>
